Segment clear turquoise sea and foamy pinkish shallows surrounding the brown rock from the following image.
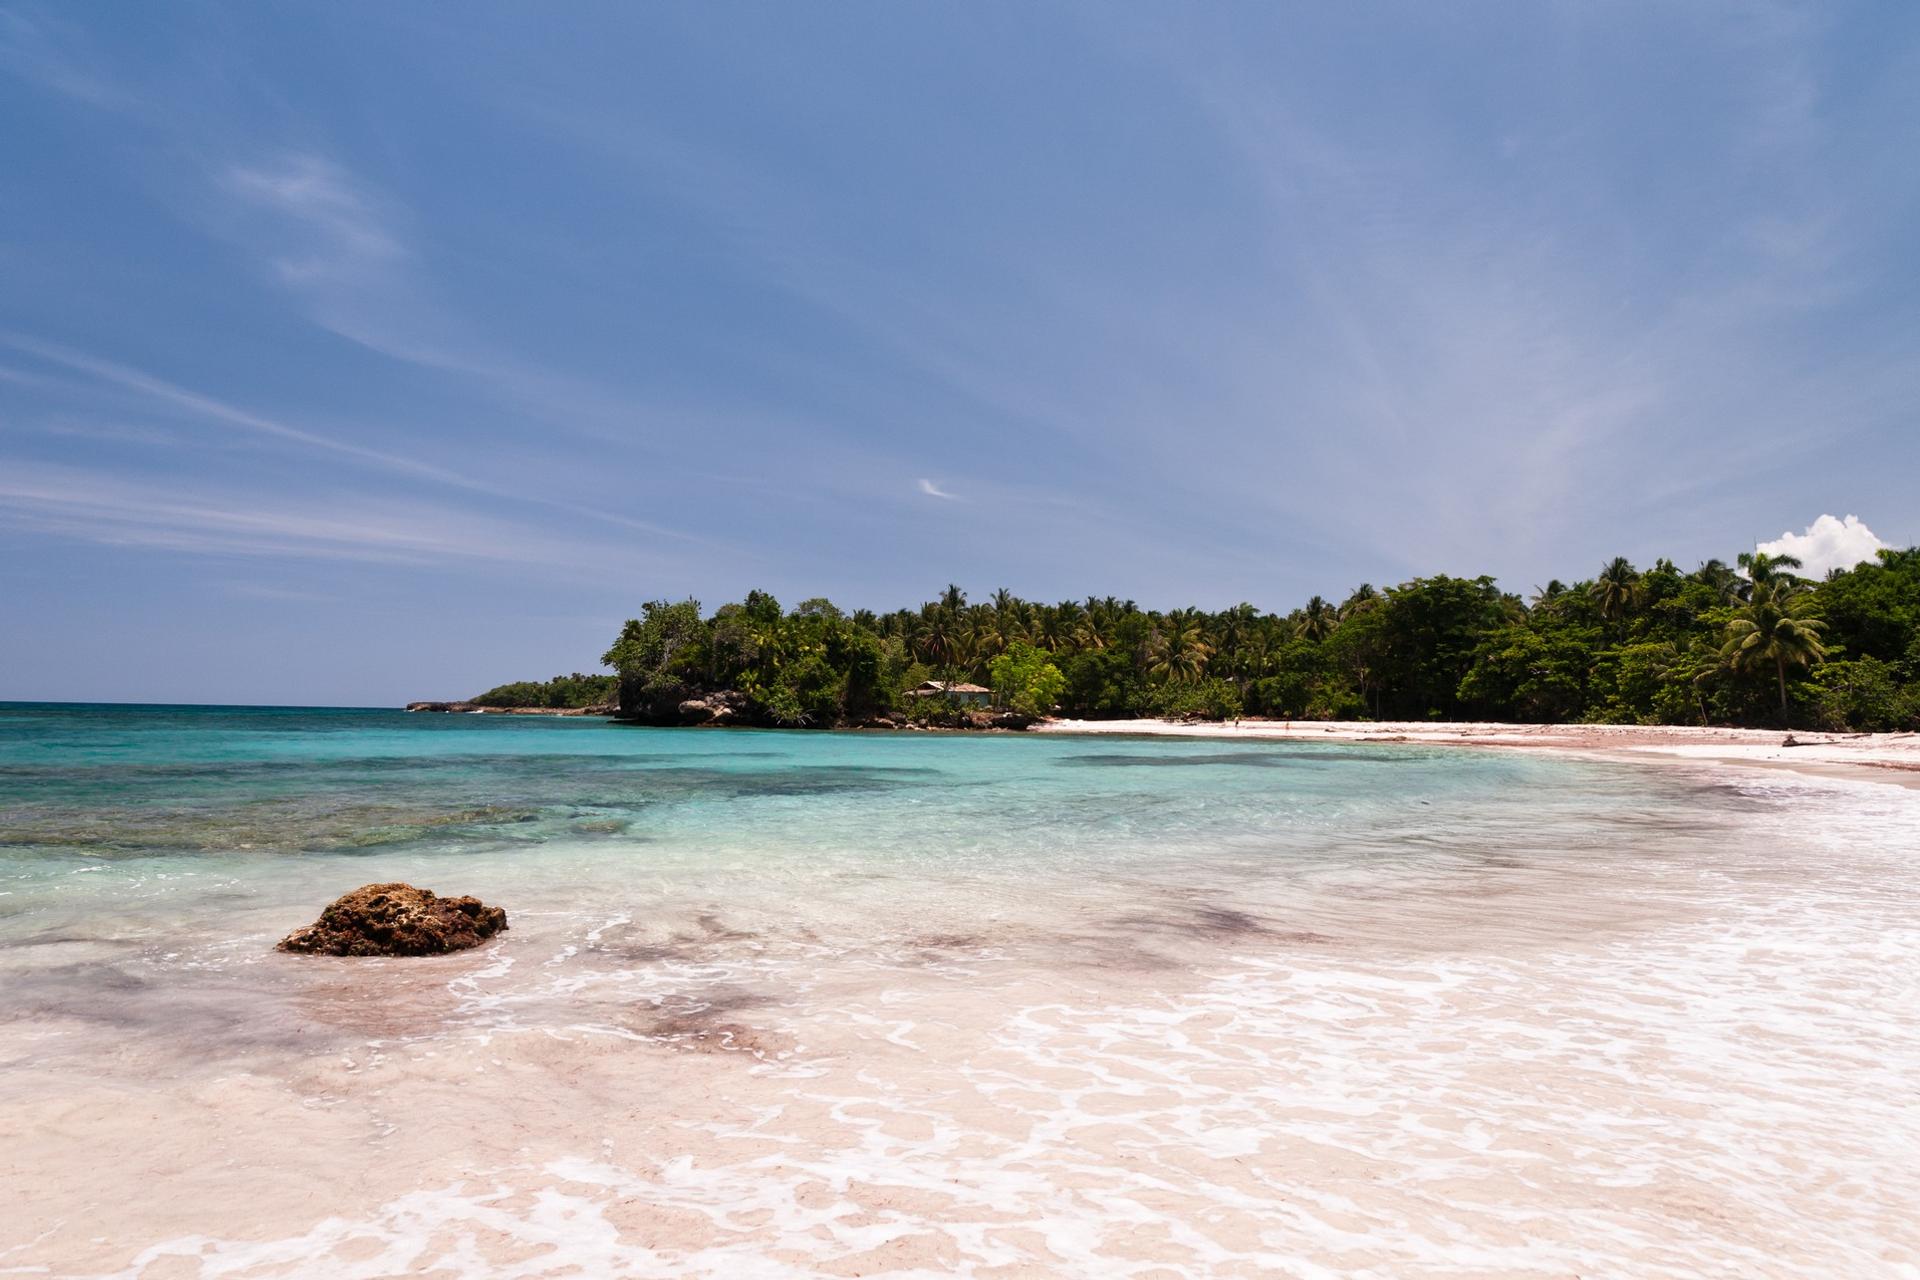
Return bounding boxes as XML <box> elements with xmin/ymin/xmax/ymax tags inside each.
<box><xmin>0</xmin><ymin>706</ymin><xmax>1920</xmax><ymax>1280</ymax></box>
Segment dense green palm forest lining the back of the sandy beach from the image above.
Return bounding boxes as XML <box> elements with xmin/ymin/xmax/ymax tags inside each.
<box><xmin>576</xmin><ymin>549</ymin><xmax>1920</xmax><ymax>729</ymax></box>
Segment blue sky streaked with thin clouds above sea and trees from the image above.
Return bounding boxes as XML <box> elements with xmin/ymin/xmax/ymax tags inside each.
<box><xmin>0</xmin><ymin>2</ymin><xmax>1920</xmax><ymax>704</ymax></box>
